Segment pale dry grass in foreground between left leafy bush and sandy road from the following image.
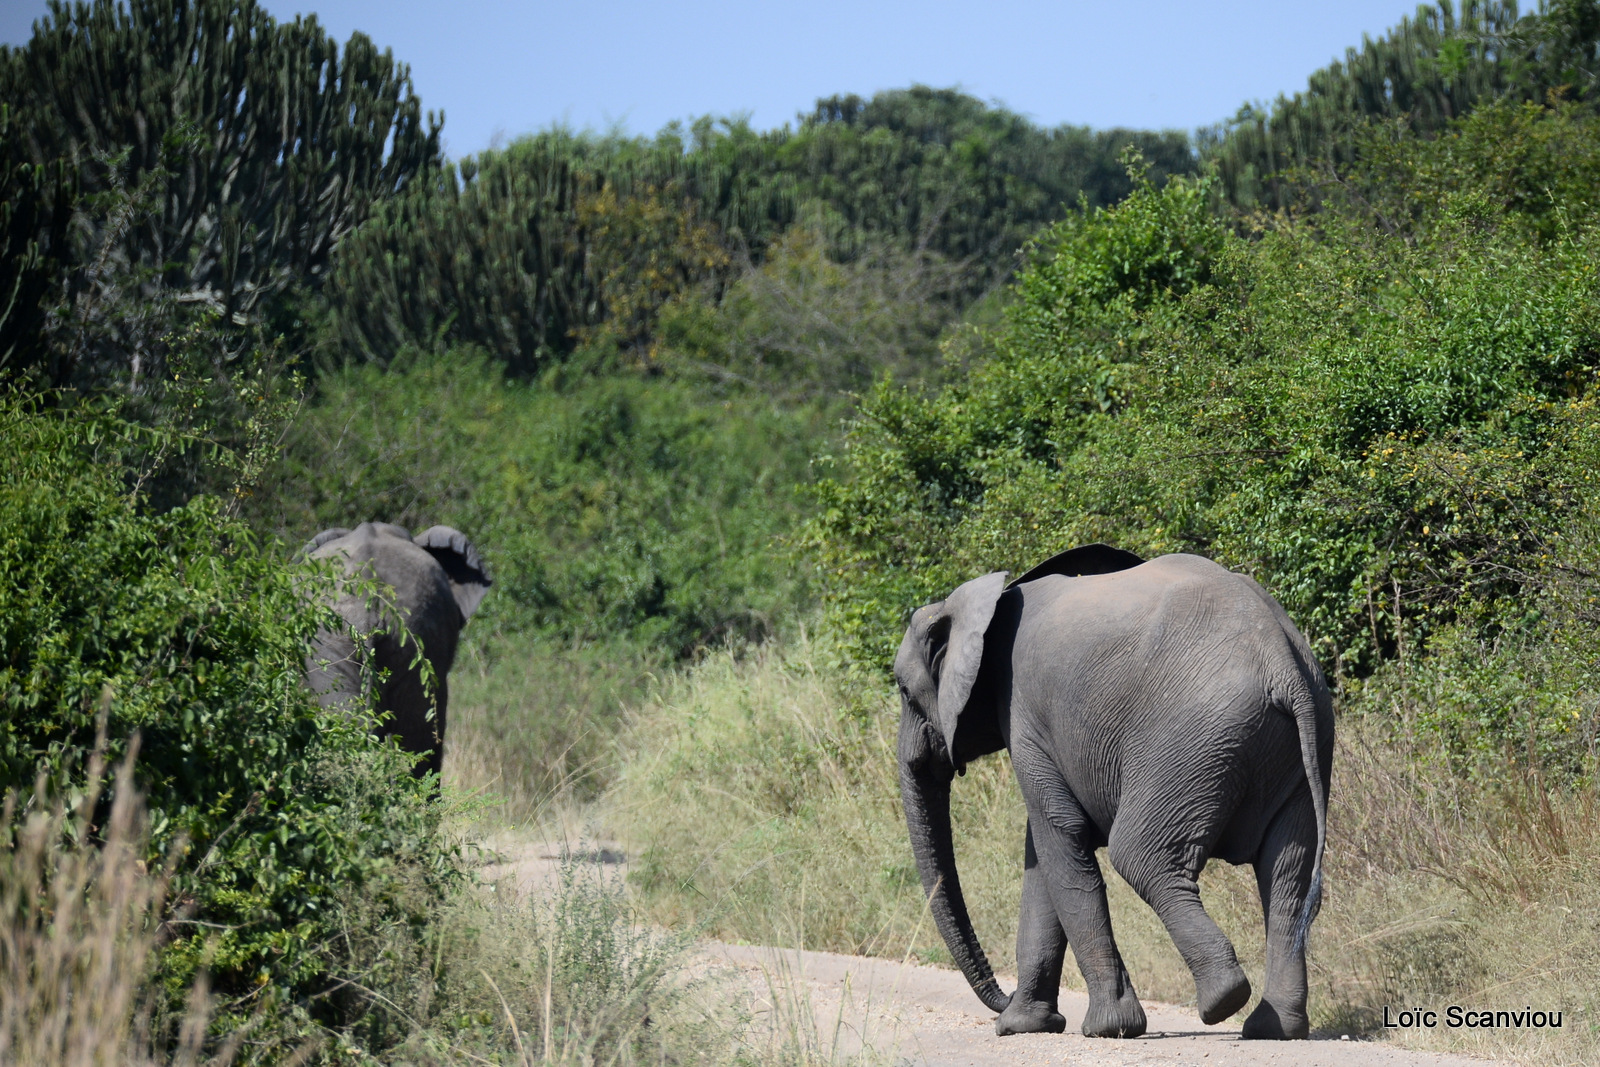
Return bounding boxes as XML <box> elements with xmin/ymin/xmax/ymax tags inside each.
<box><xmin>389</xmin><ymin>849</ymin><xmax>889</xmax><ymax>1067</ymax></box>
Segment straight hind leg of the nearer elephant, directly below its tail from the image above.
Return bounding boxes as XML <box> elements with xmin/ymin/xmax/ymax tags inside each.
<box><xmin>1240</xmin><ymin>789</ymin><xmax>1317</xmax><ymax>1040</ymax></box>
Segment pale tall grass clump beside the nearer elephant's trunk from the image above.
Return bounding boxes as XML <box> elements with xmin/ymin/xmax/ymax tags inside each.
<box><xmin>603</xmin><ymin>638</ymin><xmax>1024</xmax><ymax>960</ymax></box>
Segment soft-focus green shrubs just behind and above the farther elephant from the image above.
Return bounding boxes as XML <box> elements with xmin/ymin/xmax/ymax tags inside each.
<box><xmin>251</xmin><ymin>350</ymin><xmax>819</xmax><ymax>656</ymax></box>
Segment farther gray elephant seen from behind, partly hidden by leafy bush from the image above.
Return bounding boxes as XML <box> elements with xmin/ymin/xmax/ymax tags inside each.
<box><xmin>304</xmin><ymin>523</ymin><xmax>490</xmax><ymax>774</ymax></box>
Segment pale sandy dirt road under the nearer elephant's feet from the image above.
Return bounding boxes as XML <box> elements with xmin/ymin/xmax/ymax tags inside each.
<box><xmin>480</xmin><ymin>843</ymin><xmax>1488</xmax><ymax>1067</ymax></box>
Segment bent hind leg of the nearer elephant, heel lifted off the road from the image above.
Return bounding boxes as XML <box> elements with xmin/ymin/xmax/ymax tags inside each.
<box><xmin>1107</xmin><ymin>809</ymin><xmax>1250</xmax><ymax>1025</ymax></box>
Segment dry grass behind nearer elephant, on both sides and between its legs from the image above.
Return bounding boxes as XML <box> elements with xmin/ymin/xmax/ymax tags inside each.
<box><xmin>606</xmin><ymin>640</ymin><xmax>1600</xmax><ymax>1062</ymax></box>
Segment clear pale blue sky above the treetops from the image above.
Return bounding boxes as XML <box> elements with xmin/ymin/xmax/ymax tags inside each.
<box><xmin>0</xmin><ymin>0</ymin><xmax>1414</xmax><ymax>157</ymax></box>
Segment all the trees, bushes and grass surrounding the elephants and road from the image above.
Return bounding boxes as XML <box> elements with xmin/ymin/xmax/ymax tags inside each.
<box><xmin>9</xmin><ymin>0</ymin><xmax>1600</xmax><ymax>1064</ymax></box>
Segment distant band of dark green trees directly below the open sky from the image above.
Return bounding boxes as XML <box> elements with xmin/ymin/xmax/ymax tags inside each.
<box><xmin>330</xmin><ymin>86</ymin><xmax>1194</xmax><ymax>374</ymax></box>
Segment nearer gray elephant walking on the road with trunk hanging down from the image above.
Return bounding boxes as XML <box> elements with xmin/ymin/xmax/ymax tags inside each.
<box><xmin>894</xmin><ymin>545</ymin><xmax>1333</xmax><ymax>1038</ymax></box>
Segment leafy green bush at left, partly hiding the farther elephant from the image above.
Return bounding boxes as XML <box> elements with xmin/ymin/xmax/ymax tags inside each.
<box><xmin>0</xmin><ymin>397</ymin><xmax>453</xmax><ymax>1017</ymax></box>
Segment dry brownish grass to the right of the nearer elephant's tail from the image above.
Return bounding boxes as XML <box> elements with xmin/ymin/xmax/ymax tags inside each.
<box><xmin>1312</xmin><ymin>735</ymin><xmax>1600</xmax><ymax>1064</ymax></box>
